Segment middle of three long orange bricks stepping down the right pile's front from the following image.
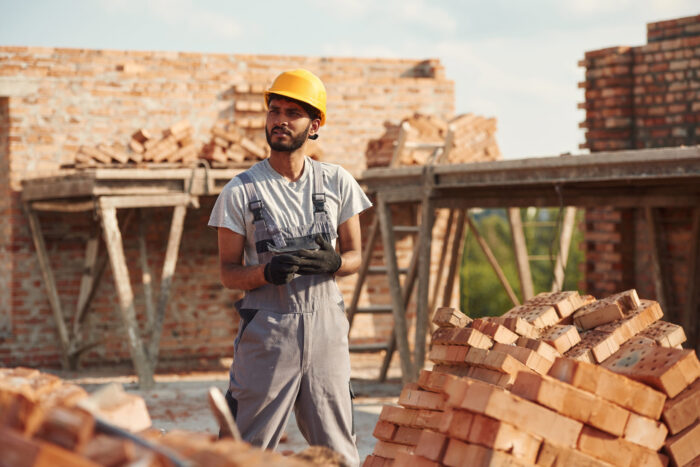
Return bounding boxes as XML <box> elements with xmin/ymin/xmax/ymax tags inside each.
<box><xmin>511</xmin><ymin>373</ymin><xmax>630</xmax><ymax>436</ymax></box>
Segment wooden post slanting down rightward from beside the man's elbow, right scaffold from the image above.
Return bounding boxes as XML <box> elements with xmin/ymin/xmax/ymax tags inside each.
<box><xmin>377</xmin><ymin>193</ymin><xmax>414</xmax><ymax>383</ymax></box>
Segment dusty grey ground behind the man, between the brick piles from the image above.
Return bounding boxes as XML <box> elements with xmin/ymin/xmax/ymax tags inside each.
<box><xmin>53</xmin><ymin>354</ymin><xmax>402</xmax><ymax>459</ymax></box>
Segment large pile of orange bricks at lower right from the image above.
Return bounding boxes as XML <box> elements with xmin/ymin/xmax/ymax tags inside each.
<box><xmin>364</xmin><ymin>290</ymin><xmax>700</xmax><ymax>467</ymax></box>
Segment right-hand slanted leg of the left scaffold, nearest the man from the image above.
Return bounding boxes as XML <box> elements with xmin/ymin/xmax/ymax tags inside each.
<box><xmin>148</xmin><ymin>204</ymin><xmax>187</xmax><ymax>367</ymax></box>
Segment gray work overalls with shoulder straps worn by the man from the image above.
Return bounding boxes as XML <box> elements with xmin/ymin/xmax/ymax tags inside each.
<box><xmin>226</xmin><ymin>161</ymin><xmax>359</xmax><ymax>465</ymax></box>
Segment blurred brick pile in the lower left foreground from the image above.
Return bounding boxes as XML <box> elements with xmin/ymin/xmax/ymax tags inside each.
<box><xmin>0</xmin><ymin>367</ymin><xmax>320</xmax><ymax>467</ymax></box>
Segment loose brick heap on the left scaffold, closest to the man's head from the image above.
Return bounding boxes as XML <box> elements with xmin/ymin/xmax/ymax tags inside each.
<box><xmin>201</xmin><ymin>121</ymin><xmax>268</xmax><ymax>167</ymax></box>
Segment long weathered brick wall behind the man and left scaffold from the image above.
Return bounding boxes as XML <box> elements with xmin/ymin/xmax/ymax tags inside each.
<box><xmin>0</xmin><ymin>47</ymin><xmax>454</xmax><ymax>366</ymax></box>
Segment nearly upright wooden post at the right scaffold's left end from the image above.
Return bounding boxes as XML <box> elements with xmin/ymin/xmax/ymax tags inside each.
<box><xmin>412</xmin><ymin>165</ymin><xmax>435</xmax><ymax>381</ymax></box>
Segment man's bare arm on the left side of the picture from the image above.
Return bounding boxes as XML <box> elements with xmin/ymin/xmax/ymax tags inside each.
<box><xmin>218</xmin><ymin>227</ymin><xmax>268</xmax><ymax>290</ymax></box>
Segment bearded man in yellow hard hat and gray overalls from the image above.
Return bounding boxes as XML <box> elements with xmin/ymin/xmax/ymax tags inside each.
<box><xmin>209</xmin><ymin>69</ymin><xmax>371</xmax><ymax>465</ymax></box>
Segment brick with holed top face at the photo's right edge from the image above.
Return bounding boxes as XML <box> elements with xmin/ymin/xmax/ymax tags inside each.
<box><xmin>603</xmin><ymin>345</ymin><xmax>700</xmax><ymax>397</ymax></box>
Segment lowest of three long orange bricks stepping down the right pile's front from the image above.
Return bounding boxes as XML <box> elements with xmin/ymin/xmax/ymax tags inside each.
<box><xmin>460</xmin><ymin>382</ymin><xmax>582</xmax><ymax>447</ymax></box>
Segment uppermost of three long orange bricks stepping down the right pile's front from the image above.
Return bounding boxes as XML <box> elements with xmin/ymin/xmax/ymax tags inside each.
<box><xmin>549</xmin><ymin>358</ymin><xmax>666</xmax><ymax>420</ymax></box>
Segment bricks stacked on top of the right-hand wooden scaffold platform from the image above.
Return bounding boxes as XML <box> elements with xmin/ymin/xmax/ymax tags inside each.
<box><xmin>365</xmin><ymin>113</ymin><xmax>501</xmax><ymax>168</ymax></box>
